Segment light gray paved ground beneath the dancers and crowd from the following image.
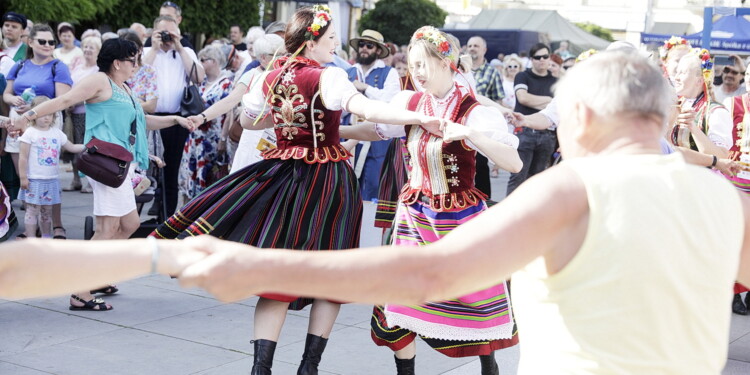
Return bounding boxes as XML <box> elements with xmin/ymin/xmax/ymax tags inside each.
<box><xmin>0</xmin><ymin>173</ymin><xmax>750</xmax><ymax>375</ymax></box>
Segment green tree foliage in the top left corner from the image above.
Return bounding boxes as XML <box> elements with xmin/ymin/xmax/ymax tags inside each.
<box><xmin>0</xmin><ymin>0</ymin><xmax>118</xmax><ymax>23</ymax></box>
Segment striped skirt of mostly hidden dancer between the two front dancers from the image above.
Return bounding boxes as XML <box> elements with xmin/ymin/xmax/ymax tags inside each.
<box><xmin>375</xmin><ymin>138</ymin><xmax>408</xmax><ymax>228</ymax></box>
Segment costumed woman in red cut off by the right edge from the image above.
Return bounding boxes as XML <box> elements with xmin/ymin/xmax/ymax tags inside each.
<box><xmin>724</xmin><ymin>66</ymin><xmax>750</xmax><ymax>315</ymax></box>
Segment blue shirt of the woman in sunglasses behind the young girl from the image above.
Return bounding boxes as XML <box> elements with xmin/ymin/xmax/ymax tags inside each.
<box><xmin>7</xmin><ymin>59</ymin><xmax>73</xmax><ymax>99</ymax></box>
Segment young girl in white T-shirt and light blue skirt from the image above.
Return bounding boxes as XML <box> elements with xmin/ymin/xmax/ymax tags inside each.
<box><xmin>18</xmin><ymin>96</ymin><xmax>84</xmax><ymax>238</ymax></box>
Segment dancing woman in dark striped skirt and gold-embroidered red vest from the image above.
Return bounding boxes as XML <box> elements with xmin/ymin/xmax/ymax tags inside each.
<box><xmin>153</xmin><ymin>5</ymin><xmax>440</xmax><ymax>374</ymax></box>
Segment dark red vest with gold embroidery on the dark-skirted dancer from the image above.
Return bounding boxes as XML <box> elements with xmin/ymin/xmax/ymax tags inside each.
<box><xmin>263</xmin><ymin>58</ymin><xmax>351</xmax><ymax>164</ymax></box>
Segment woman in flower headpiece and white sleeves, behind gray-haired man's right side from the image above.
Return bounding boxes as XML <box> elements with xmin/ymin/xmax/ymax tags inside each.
<box><xmin>670</xmin><ymin>48</ymin><xmax>733</xmax><ymax>159</ymax></box>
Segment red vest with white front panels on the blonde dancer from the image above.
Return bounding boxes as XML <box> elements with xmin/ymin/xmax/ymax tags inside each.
<box><xmin>399</xmin><ymin>88</ymin><xmax>487</xmax><ymax>212</ymax></box>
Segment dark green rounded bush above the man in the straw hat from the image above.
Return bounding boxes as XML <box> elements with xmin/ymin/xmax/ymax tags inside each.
<box><xmin>359</xmin><ymin>0</ymin><xmax>448</xmax><ymax>45</ymax></box>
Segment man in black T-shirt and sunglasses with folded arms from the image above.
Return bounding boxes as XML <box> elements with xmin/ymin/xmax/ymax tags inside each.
<box><xmin>507</xmin><ymin>43</ymin><xmax>557</xmax><ymax>195</ymax></box>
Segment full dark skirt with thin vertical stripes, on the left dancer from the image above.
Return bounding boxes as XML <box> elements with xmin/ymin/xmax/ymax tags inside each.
<box><xmin>152</xmin><ymin>159</ymin><xmax>362</xmax><ymax>310</ymax></box>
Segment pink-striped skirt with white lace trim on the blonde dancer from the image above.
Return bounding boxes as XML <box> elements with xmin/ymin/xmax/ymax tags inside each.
<box><xmin>370</xmin><ymin>203</ymin><xmax>518</xmax><ymax>357</ymax></box>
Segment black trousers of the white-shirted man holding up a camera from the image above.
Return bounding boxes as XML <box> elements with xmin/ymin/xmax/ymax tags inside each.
<box><xmin>156</xmin><ymin>113</ymin><xmax>189</xmax><ymax>217</ymax></box>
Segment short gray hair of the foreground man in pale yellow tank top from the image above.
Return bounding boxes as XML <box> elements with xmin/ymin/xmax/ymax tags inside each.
<box><xmin>555</xmin><ymin>51</ymin><xmax>674</xmax><ymax>123</ymax></box>
